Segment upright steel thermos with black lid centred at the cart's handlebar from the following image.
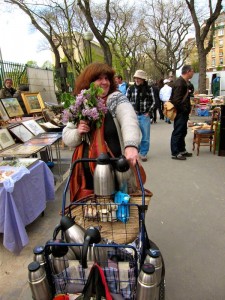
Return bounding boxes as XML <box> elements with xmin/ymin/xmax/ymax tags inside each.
<box><xmin>93</xmin><ymin>153</ymin><xmax>115</xmax><ymax>196</ymax></box>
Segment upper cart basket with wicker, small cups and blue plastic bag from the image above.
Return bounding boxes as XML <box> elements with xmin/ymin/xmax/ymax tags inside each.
<box><xmin>65</xmin><ymin>189</ymin><xmax>152</xmax><ymax>244</ymax></box>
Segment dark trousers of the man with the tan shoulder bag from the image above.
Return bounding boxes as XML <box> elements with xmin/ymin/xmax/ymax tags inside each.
<box><xmin>170</xmin><ymin>113</ymin><xmax>188</xmax><ymax>156</ymax></box>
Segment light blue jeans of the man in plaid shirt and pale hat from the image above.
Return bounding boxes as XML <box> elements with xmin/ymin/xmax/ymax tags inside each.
<box><xmin>137</xmin><ymin>115</ymin><xmax>151</xmax><ymax>156</ymax></box>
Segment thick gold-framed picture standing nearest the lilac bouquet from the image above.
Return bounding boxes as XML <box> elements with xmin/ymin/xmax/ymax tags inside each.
<box><xmin>21</xmin><ymin>92</ymin><xmax>45</xmax><ymax>114</ymax></box>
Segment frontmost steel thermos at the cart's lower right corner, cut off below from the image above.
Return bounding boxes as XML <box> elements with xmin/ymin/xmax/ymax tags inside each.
<box><xmin>136</xmin><ymin>264</ymin><xmax>157</xmax><ymax>300</ymax></box>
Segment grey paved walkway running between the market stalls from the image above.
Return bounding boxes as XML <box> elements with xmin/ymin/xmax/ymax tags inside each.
<box><xmin>0</xmin><ymin>115</ymin><xmax>225</xmax><ymax>300</ymax></box>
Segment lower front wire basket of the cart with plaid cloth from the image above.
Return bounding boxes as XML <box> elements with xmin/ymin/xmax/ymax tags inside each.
<box><xmin>45</xmin><ymin>242</ymin><xmax>138</xmax><ymax>299</ymax></box>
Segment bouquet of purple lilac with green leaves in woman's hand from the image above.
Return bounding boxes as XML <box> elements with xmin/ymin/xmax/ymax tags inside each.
<box><xmin>62</xmin><ymin>82</ymin><xmax>107</xmax><ymax>128</ymax></box>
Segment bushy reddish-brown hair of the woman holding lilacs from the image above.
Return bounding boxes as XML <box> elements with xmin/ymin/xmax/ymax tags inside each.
<box><xmin>74</xmin><ymin>62</ymin><xmax>117</xmax><ymax>95</ymax></box>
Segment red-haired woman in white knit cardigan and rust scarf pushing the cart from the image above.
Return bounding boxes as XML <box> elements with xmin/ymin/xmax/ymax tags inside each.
<box><xmin>62</xmin><ymin>62</ymin><xmax>141</xmax><ymax>202</ymax></box>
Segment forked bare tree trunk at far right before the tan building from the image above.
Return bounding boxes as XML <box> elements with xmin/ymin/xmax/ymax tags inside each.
<box><xmin>185</xmin><ymin>0</ymin><xmax>222</xmax><ymax>93</ymax></box>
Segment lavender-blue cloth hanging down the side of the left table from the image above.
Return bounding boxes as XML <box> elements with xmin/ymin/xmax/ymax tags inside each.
<box><xmin>0</xmin><ymin>161</ymin><xmax>55</xmax><ymax>254</ymax></box>
